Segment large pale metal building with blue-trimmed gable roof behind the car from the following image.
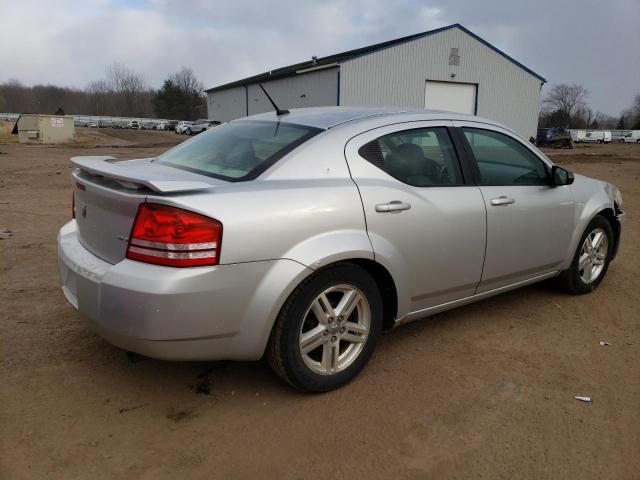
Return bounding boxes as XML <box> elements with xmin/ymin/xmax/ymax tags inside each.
<box><xmin>207</xmin><ymin>24</ymin><xmax>546</xmax><ymax>138</ymax></box>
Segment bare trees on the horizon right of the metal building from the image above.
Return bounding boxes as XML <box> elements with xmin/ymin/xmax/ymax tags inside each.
<box><xmin>538</xmin><ymin>83</ymin><xmax>640</xmax><ymax>130</ymax></box>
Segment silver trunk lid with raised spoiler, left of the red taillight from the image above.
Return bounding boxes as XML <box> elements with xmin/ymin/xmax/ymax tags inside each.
<box><xmin>71</xmin><ymin>156</ymin><xmax>227</xmax><ymax>264</ymax></box>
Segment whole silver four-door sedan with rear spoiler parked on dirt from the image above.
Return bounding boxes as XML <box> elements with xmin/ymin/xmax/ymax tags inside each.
<box><xmin>58</xmin><ymin>107</ymin><xmax>623</xmax><ymax>392</ymax></box>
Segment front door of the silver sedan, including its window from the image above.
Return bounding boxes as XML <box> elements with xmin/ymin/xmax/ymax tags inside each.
<box><xmin>454</xmin><ymin>122</ymin><xmax>575</xmax><ymax>293</ymax></box>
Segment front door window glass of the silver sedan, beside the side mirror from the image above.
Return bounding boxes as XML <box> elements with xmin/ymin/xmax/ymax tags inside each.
<box><xmin>462</xmin><ymin>128</ymin><xmax>548</xmax><ymax>186</ymax></box>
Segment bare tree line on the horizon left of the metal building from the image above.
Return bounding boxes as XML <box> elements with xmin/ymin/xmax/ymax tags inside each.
<box><xmin>0</xmin><ymin>63</ymin><xmax>207</xmax><ymax>120</ymax></box>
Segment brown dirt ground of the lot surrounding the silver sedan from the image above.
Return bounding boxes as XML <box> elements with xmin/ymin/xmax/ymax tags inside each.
<box><xmin>0</xmin><ymin>129</ymin><xmax>640</xmax><ymax>480</ymax></box>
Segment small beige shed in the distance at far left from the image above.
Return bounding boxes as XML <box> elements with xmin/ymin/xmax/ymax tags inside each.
<box><xmin>11</xmin><ymin>113</ymin><xmax>76</xmax><ymax>143</ymax></box>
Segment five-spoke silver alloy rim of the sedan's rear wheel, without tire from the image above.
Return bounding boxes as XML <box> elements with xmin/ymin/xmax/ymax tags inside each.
<box><xmin>298</xmin><ymin>285</ymin><xmax>371</xmax><ymax>375</ymax></box>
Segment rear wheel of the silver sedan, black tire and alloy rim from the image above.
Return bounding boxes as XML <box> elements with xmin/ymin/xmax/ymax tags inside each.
<box><xmin>266</xmin><ymin>263</ymin><xmax>382</xmax><ymax>393</ymax></box>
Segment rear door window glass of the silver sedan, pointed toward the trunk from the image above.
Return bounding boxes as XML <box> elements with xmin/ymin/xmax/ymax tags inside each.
<box><xmin>358</xmin><ymin>127</ymin><xmax>463</xmax><ymax>187</ymax></box>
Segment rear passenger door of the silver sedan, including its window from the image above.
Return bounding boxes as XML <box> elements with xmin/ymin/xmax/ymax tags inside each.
<box><xmin>345</xmin><ymin>122</ymin><xmax>486</xmax><ymax>317</ymax></box>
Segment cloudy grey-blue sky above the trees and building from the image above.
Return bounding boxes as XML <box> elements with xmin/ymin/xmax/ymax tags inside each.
<box><xmin>0</xmin><ymin>0</ymin><xmax>640</xmax><ymax>115</ymax></box>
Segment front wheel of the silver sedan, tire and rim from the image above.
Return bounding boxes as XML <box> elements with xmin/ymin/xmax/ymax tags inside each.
<box><xmin>556</xmin><ymin>215</ymin><xmax>615</xmax><ymax>295</ymax></box>
